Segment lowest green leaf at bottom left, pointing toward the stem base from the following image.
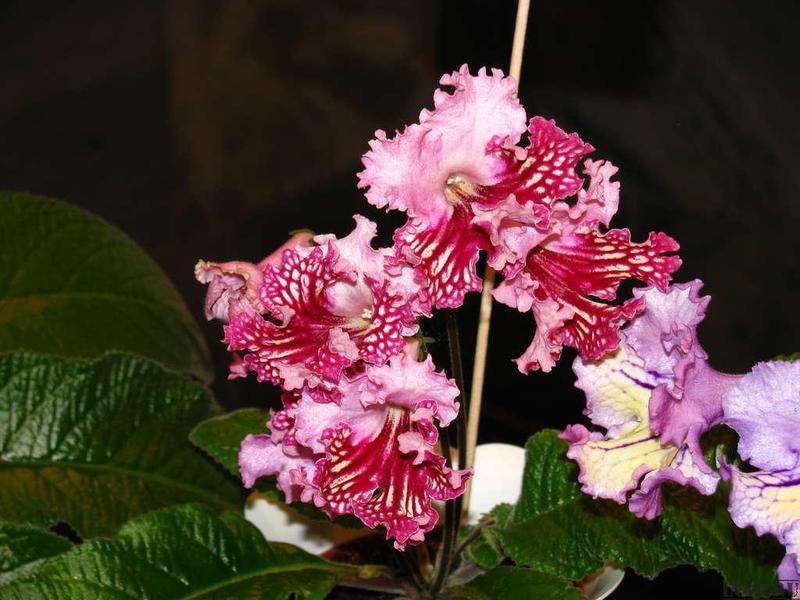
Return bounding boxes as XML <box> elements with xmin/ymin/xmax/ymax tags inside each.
<box><xmin>0</xmin><ymin>505</ymin><xmax>351</xmax><ymax>600</ymax></box>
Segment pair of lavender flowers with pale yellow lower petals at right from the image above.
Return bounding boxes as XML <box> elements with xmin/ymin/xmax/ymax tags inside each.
<box><xmin>561</xmin><ymin>281</ymin><xmax>800</xmax><ymax>582</ymax></box>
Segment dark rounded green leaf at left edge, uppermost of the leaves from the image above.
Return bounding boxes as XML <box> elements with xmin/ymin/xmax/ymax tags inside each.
<box><xmin>0</xmin><ymin>192</ymin><xmax>213</xmax><ymax>382</ymax></box>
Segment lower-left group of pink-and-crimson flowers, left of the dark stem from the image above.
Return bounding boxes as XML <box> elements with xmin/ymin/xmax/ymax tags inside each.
<box><xmin>196</xmin><ymin>215</ymin><xmax>471</xmax><ymax>548</ymax></box>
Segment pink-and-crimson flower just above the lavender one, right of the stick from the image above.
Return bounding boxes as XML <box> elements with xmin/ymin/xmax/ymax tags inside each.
<box><xmin>494</xmin><ymin>160</ymin><xmax>681</xmax><ymax>373</ymax></box>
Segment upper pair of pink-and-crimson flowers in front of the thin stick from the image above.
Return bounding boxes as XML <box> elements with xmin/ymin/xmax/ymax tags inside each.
<box><xmin>359</xmin><ymin>66</ymin><xmax>680</xmax><ymax>373</ymax></box>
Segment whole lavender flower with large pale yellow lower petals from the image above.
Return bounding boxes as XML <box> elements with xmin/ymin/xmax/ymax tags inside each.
<box><xmin>562</xmin><ymin>280</ymin><xmax>740</xmax><ymax>519</ymax></box>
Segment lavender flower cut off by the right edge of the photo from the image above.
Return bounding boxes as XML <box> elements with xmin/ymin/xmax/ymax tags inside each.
<box><xmin>722</xmin><ymin>361</ymin><xmax>800</xmax><ymax>582</ymax></box>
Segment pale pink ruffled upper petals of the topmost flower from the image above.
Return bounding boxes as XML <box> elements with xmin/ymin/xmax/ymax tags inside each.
<box><xmin>358</xmin><ymin>65</ymin><xmax>525</xmax><ymax>221</ymax></box>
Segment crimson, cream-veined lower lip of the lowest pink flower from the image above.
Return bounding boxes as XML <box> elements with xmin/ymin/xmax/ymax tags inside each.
<box><xmin>314</xmin><ymin>407</ymin><xmax>467</xmax><ymax>548</ymax></box>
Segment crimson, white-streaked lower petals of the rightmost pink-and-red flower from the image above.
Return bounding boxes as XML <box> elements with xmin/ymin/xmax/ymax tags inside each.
<box><xmin>527</xmin><ymin>229</ymin><xmax>681</xmax><ymax>360</ymax></box>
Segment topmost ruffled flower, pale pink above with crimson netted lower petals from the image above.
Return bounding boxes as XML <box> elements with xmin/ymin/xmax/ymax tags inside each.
<box><xmin>359</xmin><ymin>65</ymin><xmax>593</xmax><ymax>308</ymax></box>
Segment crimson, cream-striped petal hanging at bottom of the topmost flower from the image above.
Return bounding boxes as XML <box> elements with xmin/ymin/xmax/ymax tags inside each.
<box><xmin>394</xmin><ymin>205</ymin><xmax>488</xmax><ymax>308</ymax></box>
